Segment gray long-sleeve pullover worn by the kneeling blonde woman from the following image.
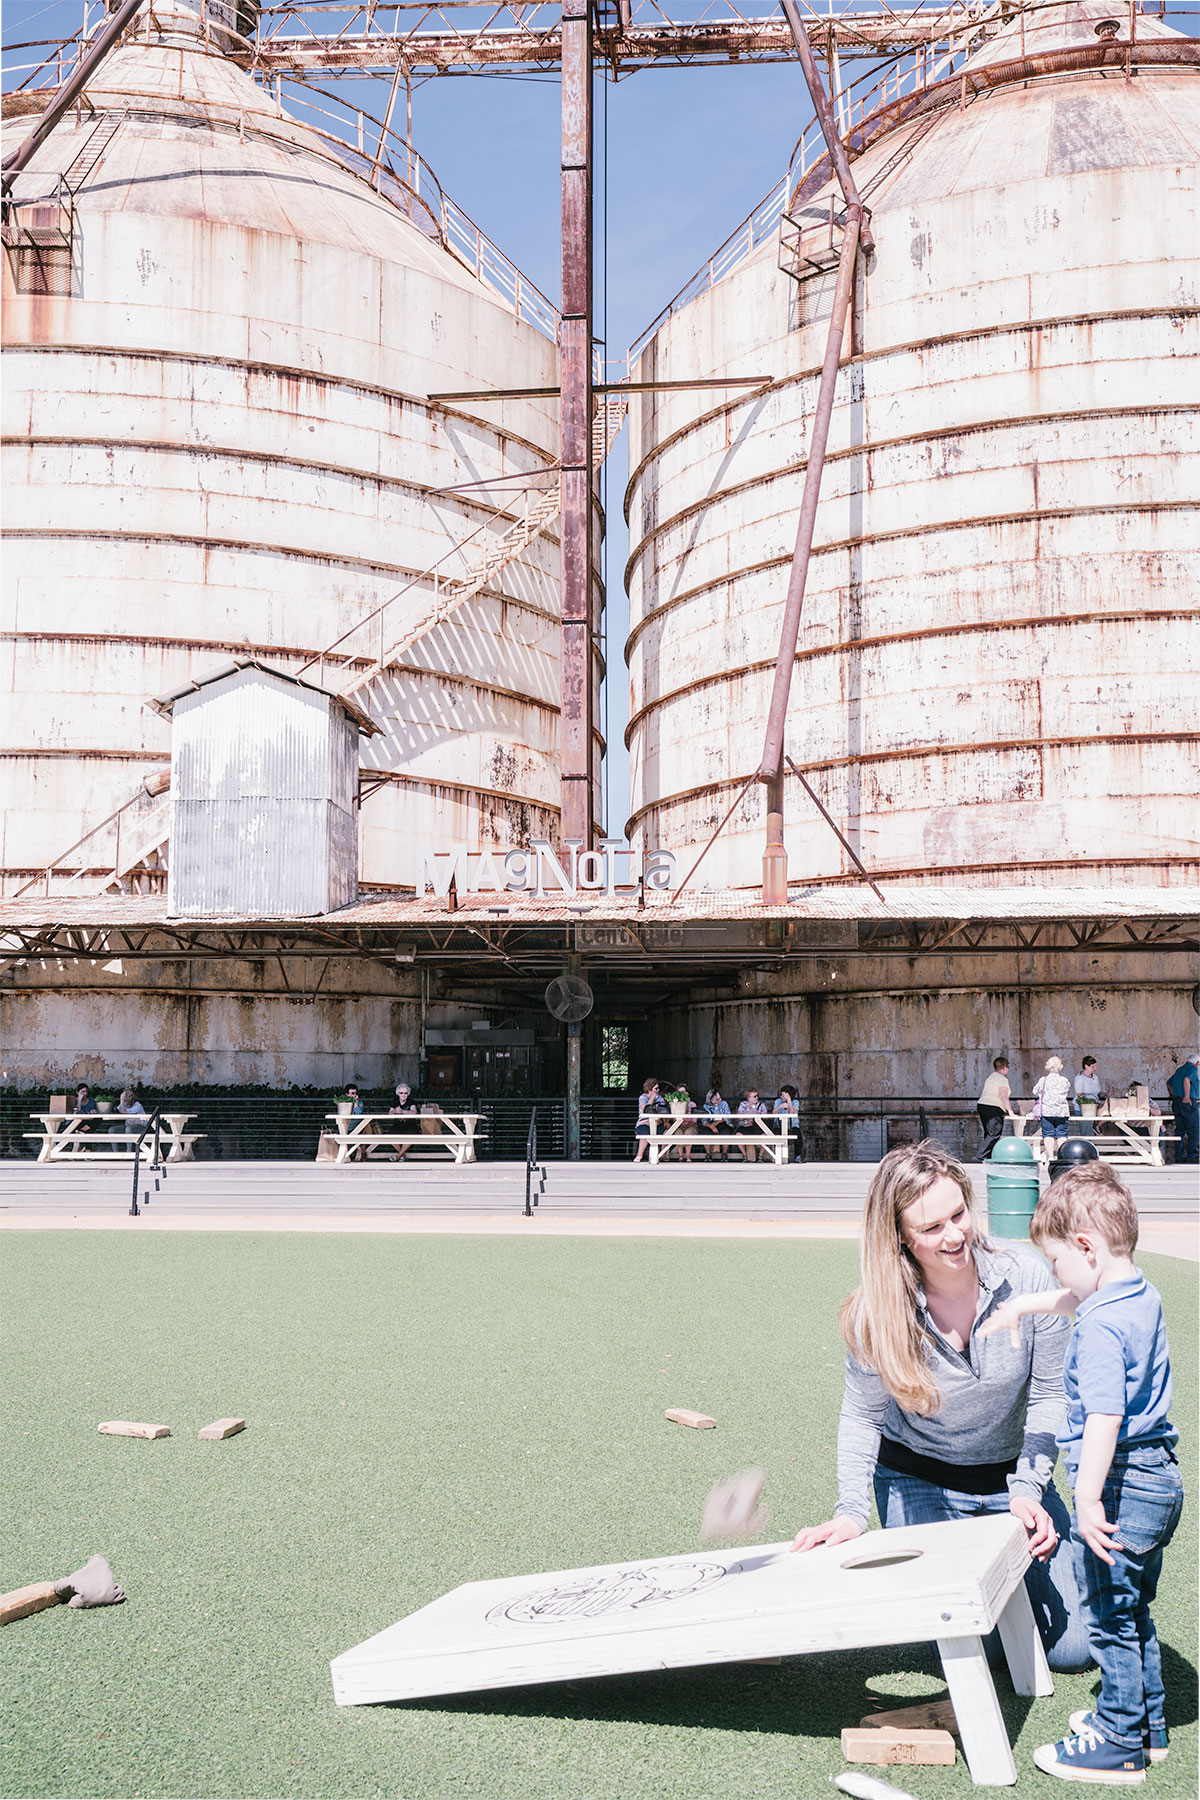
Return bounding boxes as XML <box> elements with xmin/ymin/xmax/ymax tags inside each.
<box><xmin>837</xmin><ymin>1247</ymin><xmax>1070</xmax><ymax>1530</ymax></box>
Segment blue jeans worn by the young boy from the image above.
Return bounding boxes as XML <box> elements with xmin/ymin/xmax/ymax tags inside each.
<box><xmin>1072</xmin><ymin>1444</ymin><xmax>1184</xmax><ymax>1750</ymax></box>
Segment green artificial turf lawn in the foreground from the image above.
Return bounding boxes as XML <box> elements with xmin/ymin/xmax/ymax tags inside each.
<box><xmin>0</xmin><ymin>1222</ymin><xmax>1196</xmax><ymax>1800</ymax></box>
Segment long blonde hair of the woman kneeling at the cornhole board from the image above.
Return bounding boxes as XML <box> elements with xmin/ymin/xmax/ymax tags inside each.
<box><xmin>840</xmin><ymin>1139</ymin><xmax>986</xmax><ymax>1415</ymax></box>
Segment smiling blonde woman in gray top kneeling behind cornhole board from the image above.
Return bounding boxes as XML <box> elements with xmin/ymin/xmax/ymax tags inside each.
<box><xmin>792</xmin><ymin>1141</ymin><xmax>1090</xmax><ymax>1670</ymax></box>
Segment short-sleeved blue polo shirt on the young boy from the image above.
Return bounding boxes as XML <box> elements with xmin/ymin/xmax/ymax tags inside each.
<box><xmin>1058</xmin><ymin>1269</ymin><xmax>1178</xmax><ymax>1471</ymax></box>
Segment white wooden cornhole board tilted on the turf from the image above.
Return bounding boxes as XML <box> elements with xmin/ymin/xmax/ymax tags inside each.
<box><xmin>331</xmin><ymin>1512</ymin><xmax>1054</xmax><ymax>1787</ymax></box>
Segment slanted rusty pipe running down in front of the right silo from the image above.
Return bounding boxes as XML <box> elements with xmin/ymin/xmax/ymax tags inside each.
<box><xmin>757</xmin><ymin>203</ymin><xmax>862</xmax><ymax>905</ymax></box>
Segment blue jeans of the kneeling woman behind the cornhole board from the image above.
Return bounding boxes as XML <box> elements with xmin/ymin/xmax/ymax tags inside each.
<box><xmin>874</xmin><ymin>1467</ymin><xmax>1101</xmax><ymax>1670</ymax></box>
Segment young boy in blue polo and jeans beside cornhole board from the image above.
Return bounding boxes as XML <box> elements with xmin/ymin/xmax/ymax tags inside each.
<box><xmin>984</xmin><ymin>1163</ymin><xmax>1184</xmax><ymax>1786</ymax></box>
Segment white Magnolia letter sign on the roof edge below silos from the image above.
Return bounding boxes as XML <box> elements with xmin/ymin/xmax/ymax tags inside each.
<box><xmin>417</xmin><ymin>837</ymin><xmax>676</xmax><ymax>900</ymax></box>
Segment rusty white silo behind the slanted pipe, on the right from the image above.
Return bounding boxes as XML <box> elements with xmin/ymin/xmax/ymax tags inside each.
<box><xmin>626</xmin><ymin>0</ymin><xmax>1200</xmax><ymax>887</ymax></box>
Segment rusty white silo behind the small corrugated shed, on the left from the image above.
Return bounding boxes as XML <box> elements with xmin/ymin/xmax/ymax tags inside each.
<box><xmin>0</xmin><ymin>4</ymin><xmax>601</xmax><ymax>891</ymax></box>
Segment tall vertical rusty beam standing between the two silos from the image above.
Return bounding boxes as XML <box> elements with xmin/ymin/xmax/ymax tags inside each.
<box><xmin>558</xmin><ymin>0</ymin><xmax>594</xmax><ymax>849</ymax></box>
